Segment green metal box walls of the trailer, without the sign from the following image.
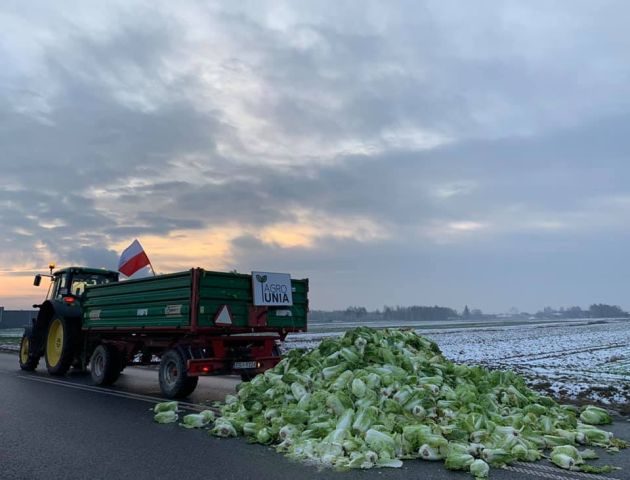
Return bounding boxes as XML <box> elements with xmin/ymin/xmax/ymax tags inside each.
<box><xmin>82</xmin><ymin>269</ymin><xmax>308</xmax><ymax>334</ymax></box>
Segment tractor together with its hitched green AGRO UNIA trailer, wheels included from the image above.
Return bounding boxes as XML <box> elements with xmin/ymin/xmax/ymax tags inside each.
<box><xmin>20</xmin><ymin>267</ymin><xmax>308</xmax><ymax>398</ymax></box>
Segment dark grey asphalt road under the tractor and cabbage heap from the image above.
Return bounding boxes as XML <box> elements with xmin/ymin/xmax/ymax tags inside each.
<box><xmin>0</xmin><ymin>353</ymin><xmax>630</xmax><ymax>480</ymax></box>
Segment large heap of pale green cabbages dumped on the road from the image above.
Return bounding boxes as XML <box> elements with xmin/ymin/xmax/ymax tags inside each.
<box><xmin>159</xmin><ymin>327</ymin><xmax>625</xmax><ymax>478</ymax></box>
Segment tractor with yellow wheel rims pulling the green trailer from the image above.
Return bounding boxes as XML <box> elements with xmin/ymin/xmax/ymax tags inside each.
<box><xmin>20</xmin><ymin>264</ymin><xmax>118</xmax><ymax>376</ymax></box>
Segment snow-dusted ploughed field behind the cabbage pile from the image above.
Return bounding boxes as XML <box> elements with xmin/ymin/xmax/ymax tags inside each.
<box><xmin>285</xmin><ymin>320</ymin><xmax>630</xmax><ymax>412</ymax></box>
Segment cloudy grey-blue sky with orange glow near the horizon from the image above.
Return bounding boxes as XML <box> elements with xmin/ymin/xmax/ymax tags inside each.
<box><xmin>0</xmin><ymin>0</ymin><xmax>630</xmax><ymax>312</ymax></box>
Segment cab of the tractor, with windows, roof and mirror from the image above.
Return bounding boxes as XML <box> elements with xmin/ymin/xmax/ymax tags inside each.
<box><xmin>33</xmin><ymin>266</ymin><xmax>118</xmax><ymax>301</ymax></box>
